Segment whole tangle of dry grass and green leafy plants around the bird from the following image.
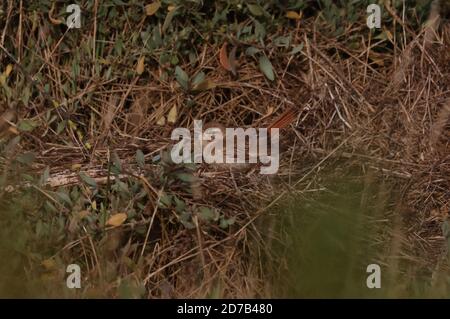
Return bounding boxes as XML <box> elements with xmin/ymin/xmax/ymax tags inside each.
<box><xmin>0</xmin><ymin>0</ymin><xmax>450</xmax><ymax>298</ymax></box>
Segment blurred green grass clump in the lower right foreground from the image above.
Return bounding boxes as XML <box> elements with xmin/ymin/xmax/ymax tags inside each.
<box><xmin>269</xmin><ymin>172</ymin><xmax>450</xmax><ymax>298</ymax></box>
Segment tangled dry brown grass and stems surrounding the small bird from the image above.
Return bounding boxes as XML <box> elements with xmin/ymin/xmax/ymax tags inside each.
<box><xmin>0</xmin><ymin>1</ymin><xmax>450</xmax><ymax>298</ymax></box>
